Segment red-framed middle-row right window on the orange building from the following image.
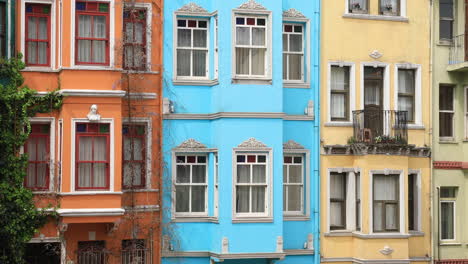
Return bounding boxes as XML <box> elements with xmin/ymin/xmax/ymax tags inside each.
<box><xmin>122</xmin><ymin>124</ymin><xmax>147</xmax><ymax>189</ymax></box>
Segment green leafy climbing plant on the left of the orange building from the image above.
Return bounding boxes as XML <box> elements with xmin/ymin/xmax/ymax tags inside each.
<box><xmin>0</xmin><ymin>55</ymin><xmax>63</xmax><ymax>264</ymax></box>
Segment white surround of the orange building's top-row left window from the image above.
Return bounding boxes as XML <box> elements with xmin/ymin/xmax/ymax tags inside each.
<box><xmin>19</xmin><ymin>0</ymin><xmax>58</xmax><ymax>71</ymax></box>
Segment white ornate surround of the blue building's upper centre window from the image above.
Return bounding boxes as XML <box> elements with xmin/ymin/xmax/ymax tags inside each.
<box><xmin>231</xmin><ymin>9</ymin><xmax>273</xmax><ymax>81</ymax></box>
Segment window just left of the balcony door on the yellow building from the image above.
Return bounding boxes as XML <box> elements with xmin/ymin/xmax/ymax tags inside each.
<box><xmin>330</xmin><ymin>65</ymin><xmax>350</xmax><ymax>121</ymax></box>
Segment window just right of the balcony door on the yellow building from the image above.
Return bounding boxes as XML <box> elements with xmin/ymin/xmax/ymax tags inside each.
<box><xmin>398</xmin><ymin>69</ymin><xmax>416</xmax><ymax>123</ymax></box>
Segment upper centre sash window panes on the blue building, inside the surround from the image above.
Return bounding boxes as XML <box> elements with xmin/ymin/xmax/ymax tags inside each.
<box><xmin>234</xmin><ymin>15</ymin><xmax>271</xmax><ymax>78</ymax></box>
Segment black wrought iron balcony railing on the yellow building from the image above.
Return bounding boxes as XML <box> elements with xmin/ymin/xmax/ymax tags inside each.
<box><xmin>352</xmin><ymin>109</ymin><xmax>408</xmax><ymax>145</ymax></box>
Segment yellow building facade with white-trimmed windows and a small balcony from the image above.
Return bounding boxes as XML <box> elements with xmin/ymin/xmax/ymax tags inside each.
<box><xmin>320</xmin><ymin>0</ymin><xmax>431</xmax><ymax>264</ymax></box>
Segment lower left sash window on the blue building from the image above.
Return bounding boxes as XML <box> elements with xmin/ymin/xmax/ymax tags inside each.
<box><xmin>175</xmin><ymin>154</ymin><xmax>208</xmax><ymax>214</ymax></box>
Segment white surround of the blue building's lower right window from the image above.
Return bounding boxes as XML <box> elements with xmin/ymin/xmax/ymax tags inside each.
<box><xmin>283</xmin><ymin>149</ymin><xmax>310</xmax><ymax>221</ymax></box>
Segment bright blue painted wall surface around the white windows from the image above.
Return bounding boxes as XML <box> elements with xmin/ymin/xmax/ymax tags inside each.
<box><xmin>162</xmin><ymin>0</ymin><xmax>320</xmax><ymax>264</ymax></box>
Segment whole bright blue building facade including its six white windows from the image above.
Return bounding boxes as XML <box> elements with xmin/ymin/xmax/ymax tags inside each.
<box><xmin>161</xmin><ymin>0</ymin><xmax>320</xmax><ymax>264</ymax></box>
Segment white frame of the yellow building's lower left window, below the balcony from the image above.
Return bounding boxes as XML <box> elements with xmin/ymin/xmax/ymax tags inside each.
<box><xmin>326</xmin><ymin>168</ymin><xmax>363</xmax><ymax>233</ymax></box>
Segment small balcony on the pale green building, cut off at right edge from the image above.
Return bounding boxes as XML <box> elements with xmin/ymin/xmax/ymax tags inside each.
<box><xmin>447</xmin><ymin>34</ymin><xmax>468</xmax><ymax>72</ymax></box>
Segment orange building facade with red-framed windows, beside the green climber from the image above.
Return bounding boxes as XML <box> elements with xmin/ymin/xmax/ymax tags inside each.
<box><xmin>15</xmin><ymin>0</ymin><xmax>163</xmax><ymax>264</ymax></box>
